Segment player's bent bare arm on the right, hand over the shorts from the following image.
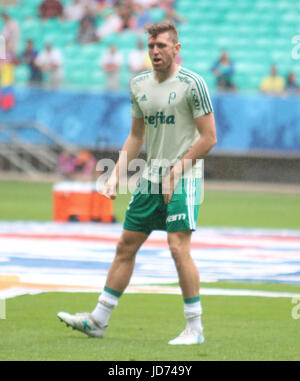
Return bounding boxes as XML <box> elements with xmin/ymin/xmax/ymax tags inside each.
<box><xmin>164</xmin><ymin>112</ymin><xmax>217</xmax><ymax>203</ymax></box>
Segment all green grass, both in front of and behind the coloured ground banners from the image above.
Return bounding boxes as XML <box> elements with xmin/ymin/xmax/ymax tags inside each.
<box><xmin>0</xmin><ymin>182</ymin><xmax>300</xmax><ymax>361</ymax></box>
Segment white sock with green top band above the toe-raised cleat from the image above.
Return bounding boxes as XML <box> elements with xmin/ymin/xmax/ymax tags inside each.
<box><xmin>92</xmin><ymin>286</ymin><xmax>121</xmax><ymax>325</ymax></box>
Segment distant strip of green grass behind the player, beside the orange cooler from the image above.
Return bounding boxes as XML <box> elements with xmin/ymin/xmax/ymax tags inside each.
<box><xmin>0</xmin><ymin>181</ymin><xmax>300</xmax><ymax>229</ymax></box>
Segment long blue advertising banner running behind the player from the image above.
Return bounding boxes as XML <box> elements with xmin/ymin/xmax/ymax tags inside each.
<box><xmin>0</xmin><ymin>88</ymin><xmax>300</xmax><ymax>153</ymax></box>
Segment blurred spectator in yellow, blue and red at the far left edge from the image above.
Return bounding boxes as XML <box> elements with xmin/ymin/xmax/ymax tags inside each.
<box><xmin>0</xmin><ymin>41</ymin><xmax>15</xmax><ymax>110</ymax></box>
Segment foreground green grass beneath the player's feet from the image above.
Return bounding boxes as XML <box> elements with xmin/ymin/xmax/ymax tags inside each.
<box><xmin>0</xmin><ymin>293</ymin><xmax>300</xmax><ymax>361</ymax></box>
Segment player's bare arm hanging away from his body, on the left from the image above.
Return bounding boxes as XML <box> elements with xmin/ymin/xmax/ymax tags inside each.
<box><xmin>102</xmin><ymin>117</ymin><xmax>145</xmax><ymax>200</ymax></box>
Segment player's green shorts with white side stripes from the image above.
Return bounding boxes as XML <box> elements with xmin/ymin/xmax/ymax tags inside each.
<box><xmin>124</xmin><ymin>177</ymin><xmax>202</xmax><ymax>234</ymax></box>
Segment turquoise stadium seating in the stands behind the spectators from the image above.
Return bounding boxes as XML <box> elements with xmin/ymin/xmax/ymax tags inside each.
<box><xmin>4</xmin><ymin>0</ymin><xmax>300</xmax><ymax>91</ymax></box>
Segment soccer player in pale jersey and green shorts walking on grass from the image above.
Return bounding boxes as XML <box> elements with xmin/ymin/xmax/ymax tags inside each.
<box><xmin>58</xmin><ymin>22</ymin><xmax>217</xmax><ymax>345</ymax></box>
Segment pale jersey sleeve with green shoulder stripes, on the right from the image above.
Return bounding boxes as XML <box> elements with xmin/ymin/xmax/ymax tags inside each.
<box><xmin>188</xmin><ymin>76</ymin><xmax>213</xmax><ymax>119</ymax></box>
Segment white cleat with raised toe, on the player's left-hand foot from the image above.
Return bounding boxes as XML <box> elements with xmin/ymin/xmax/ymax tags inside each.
<box><xmin>57</xmin><ymin>312</ymin><xmax>107</xmax><ymax>338</ymax></box>
